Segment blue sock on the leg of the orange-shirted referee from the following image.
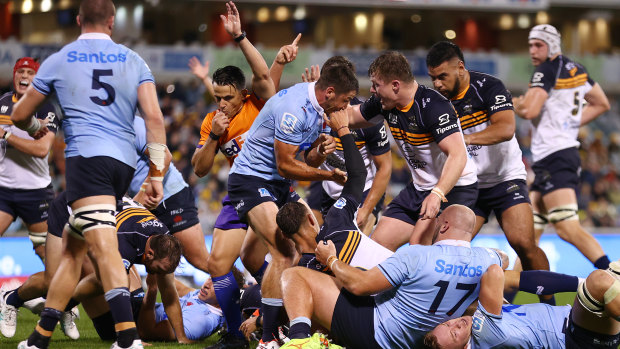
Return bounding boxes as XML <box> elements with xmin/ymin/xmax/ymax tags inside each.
<box><xmin>212</xmin><ymin>272</ymin><xmax>245</xmax><ymax>338</ymax></box>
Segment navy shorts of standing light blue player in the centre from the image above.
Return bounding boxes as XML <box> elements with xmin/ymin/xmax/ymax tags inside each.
<box><xmin>228</xmin><ymin>173</ymin><xmax>300</xmax><ymax>223</ymax></box>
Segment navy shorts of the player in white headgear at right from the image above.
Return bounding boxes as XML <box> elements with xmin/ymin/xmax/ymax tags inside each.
<box><xmin>530</xmin><ymin>148</ymin><xmax>581</xmax><ymax>196</ymax></box>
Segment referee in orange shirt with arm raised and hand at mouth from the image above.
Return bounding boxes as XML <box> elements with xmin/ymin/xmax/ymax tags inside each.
<box><xmin>192</xmin><ymin>2</ymin><xmax>300</xmax><ymax>349</ymax></box>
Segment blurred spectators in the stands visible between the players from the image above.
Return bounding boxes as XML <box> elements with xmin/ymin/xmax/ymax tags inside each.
<box><xmin>0</xmin><ymin>80</ymin><xmax>620</xmax><ymax>234</ymax></box>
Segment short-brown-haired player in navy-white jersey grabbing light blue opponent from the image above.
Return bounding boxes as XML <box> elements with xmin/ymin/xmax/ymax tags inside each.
<box><xmin>350</xmin><ymin>51</ymin><xmax>478</xmax><ymax>247</ymax></box>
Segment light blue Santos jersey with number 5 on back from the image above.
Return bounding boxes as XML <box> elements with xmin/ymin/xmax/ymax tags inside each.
<box><xmin>32</xmin><ymin>33</ymin><xmax>154</xmax><ymax>167</ymax></box>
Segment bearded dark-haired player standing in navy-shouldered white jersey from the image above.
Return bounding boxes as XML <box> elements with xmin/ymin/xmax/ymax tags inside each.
<box><xmin>426</xmin><ymin>41</ymin><xmax>549</xmax><ymax>278</ymax></box>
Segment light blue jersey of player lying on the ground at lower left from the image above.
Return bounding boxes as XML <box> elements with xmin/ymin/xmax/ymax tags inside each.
<box><xmin>155</xmin><ymin>290</ymin><xmax>224</xmax><ymax>341</ymax></box>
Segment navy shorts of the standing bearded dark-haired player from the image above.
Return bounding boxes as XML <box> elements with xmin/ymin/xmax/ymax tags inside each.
<box><xmin>474</xmin><ymin>179</ymin><xmax>530</xmax><ymax>222</ymax></box>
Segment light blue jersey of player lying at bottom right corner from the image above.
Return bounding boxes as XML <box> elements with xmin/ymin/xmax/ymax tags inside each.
<box><xmin>471</xmin><ymin>303</ymin><xmax>571</xmax><ymax>349</ymax></box>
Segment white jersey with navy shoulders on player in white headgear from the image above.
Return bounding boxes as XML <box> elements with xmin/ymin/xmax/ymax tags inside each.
<box><xmin>530</xmin><ymin>55</ymin><xmax>595</xmax><ymax>162</ymax></box>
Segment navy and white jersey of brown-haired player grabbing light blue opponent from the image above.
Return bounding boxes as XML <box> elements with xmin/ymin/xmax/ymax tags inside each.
<box><xmin>360</xmin><ymin>85</ymin><xmax>477</xmax><ymax>191</ymax></box>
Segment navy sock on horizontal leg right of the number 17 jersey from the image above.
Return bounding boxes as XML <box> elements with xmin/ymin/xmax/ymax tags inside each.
<box><xmin>519</xmin><ymin>270</ymin><xmax>579</xmax><ymax>295</ymax></box>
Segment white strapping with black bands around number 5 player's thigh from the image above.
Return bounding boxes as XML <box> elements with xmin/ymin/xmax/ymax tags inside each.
<box><xmin>67</xmin><ymin>204</ymin><xmax>116</xmax><ymax>239</ymax></box>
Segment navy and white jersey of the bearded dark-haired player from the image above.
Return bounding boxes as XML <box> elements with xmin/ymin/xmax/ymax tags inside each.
<box><xmin>452</xmin><ymin>71</ymin><xmax>527</xmax><ymax>188</ymax></box>
